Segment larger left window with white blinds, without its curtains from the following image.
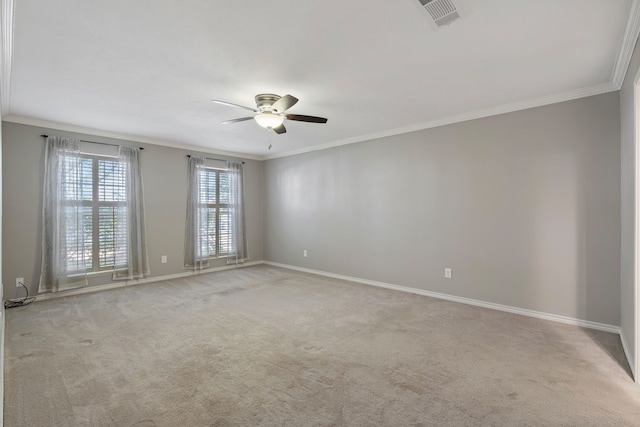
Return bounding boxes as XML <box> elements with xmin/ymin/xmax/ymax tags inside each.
<box><xmin>62</xmin><ymin>154</ymin><xmax>127</xmax><ymax>273</ymax></box>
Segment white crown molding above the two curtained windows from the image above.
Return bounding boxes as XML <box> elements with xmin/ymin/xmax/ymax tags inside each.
<box><xmin>2</xmin><ymin>115</ymin><xmax>263</xmax><ymax>160</ymax></box>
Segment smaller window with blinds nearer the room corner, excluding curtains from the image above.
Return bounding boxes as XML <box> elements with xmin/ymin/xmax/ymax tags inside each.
<box><xmin>198</xmin><ymin>168</ymin><xmax>231</xmax><ymax>258</ymax></box>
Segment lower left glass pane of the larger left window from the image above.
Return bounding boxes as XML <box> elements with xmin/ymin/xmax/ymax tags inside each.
<box><xmin>64</xmin><ymin>205</ymin><xmax>93</xmax><ymax>273</ymax></box>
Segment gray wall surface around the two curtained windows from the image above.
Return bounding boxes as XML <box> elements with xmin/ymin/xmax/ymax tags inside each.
<box><xmin>2</xmin><ymin>122</ymin><xmax>264</xmax><ymax>298</ymax></box>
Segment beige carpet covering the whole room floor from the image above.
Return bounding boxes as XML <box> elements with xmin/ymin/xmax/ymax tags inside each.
<box><xmin>5</xmin><ymin>266</ymin><xmax>640</xmax><ymax>427</ymax></box>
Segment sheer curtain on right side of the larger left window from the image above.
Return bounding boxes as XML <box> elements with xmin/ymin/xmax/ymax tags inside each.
<box><xmin>113</xmin><ymin>146</ymin><xmax>150</xmax><ymax>280</ymax></box>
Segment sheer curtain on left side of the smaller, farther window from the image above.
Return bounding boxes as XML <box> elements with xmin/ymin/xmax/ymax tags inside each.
<box><xmin>184</xmin><ymin>156</ymin><xmax>210</xmax><ymax>270</ymax></box>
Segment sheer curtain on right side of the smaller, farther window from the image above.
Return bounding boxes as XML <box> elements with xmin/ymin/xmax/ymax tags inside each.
<box><xmin>226</xmin><ymin>161</ymin><xmax>249</xmax><ymax>264</ymax></box>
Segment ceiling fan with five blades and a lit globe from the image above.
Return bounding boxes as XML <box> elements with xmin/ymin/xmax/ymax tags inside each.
<box><xmin>211</xmin><ymin>93</ymin><xmax>327</xmax><ymax>134</ymax></box>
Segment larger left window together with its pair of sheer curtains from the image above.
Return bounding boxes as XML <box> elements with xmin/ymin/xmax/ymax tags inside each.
<box><xmin>39</xmin><ymin>136</ymin><xmax>150</xmax><ymax>292</ymax></box>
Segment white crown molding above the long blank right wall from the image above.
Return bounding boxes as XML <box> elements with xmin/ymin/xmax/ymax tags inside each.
<box><xmin>263</xmin><ymin>83</ymin><xmax>620</xmax><ymax>160</ymax></box>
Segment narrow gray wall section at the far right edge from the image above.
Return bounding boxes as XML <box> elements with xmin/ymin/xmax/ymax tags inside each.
<box><xmin>620</xmin><ymin>34</ymin><xmax>640</xmax><ymax>380</ymax></box>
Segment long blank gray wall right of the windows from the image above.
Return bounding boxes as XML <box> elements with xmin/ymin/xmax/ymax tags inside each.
<box><xmin>264</xmin><ymin>92</ymin><xmax>620</xmax><ymax>325</ymax></box>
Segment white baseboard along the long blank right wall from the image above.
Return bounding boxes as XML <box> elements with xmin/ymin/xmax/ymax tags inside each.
<box><xmin>264</xmin><ymin>261</ymin><xmax>620</xmax><ymax>335</ymax></box>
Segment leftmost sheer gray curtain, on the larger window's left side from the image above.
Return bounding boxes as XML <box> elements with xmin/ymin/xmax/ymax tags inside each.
<box><xmin>39</xmin><ymin>136</ymin><xmax>91</xmax><ymax>292</ymax></box>
